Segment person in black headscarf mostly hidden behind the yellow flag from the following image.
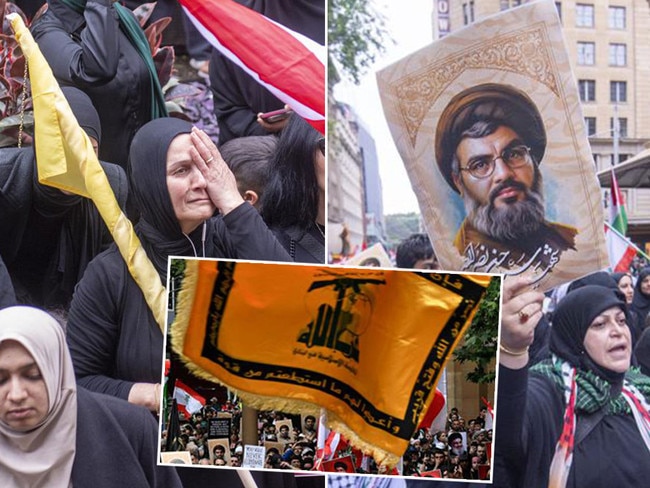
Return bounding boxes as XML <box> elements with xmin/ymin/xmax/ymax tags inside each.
<box><xmin>0</xmin><ymin>87</ymin><xmax>127</xmax><ymax>309</ymax></box>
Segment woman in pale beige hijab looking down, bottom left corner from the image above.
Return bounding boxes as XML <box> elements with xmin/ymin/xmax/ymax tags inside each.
<box><xmin>0</xmin><ymin>307</ymin><xmax>181</xmax><ymax>488</ymax></box>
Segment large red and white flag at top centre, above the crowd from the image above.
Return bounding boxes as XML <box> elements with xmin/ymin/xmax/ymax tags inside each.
<box><xmin>180</xmin><ymin>0</ymin><xmax>327</xmax><ymax>134</ymax></box>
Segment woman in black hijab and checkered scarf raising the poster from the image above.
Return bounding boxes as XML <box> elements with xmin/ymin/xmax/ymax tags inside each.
<box><xmin>495</xmin><ymin>279</ymin><xmax>650</xmax><ymax>488</ymax></box>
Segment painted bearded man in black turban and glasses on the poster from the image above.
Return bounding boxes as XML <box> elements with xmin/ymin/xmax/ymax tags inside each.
<box><xmin>435</xmin><ymin>84</ymin><xmax>577</xmax><ymax>271</ymax></box>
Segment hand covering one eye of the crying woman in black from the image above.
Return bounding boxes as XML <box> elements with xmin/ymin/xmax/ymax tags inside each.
<box><xmin>190</xmin><ymin>127</ymin><xmax>244</xmax><ymax>215</ymax></box>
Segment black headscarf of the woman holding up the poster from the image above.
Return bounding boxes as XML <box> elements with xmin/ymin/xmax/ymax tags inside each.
<box><xmin>550</xmin><ymin>285</ymin><xmax>626</xmax><ymax>383</ymax></box>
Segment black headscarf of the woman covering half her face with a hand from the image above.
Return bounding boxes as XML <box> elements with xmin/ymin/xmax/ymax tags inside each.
<box><xmin>129</xmin><ymin>117</ymin><xmax>212</xmax><ymax>283</ymax></box>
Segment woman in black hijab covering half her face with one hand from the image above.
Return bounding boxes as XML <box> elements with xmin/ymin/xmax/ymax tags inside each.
<box><xmin>68</xmin><ymin>118</ymin><xmax>290</xmax><ymax>411</ymax></box>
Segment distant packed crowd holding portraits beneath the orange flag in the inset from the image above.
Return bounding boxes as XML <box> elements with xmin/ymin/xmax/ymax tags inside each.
<box><xmin>161</xmin><ymin>397</ymin><xmax>492</xmax><ymax>480</ymax></box>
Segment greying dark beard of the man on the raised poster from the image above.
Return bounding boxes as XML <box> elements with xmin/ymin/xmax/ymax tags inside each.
<box><xmin>463</xmin><ymin>175</ymin><xmax>545</xmax><ymax>242</ymax></box>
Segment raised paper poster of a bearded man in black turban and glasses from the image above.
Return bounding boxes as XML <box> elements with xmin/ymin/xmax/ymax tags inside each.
<box><xmin>377</xmin><ymin>1</ymin><xmax>608</xmax><ymax>290</ymax></box>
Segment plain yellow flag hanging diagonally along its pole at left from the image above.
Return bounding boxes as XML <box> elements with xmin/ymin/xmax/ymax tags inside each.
<box><xmin>7</xmin><ymin>13</ymin><xmax>166</xmax><ymax>329</ymax></box>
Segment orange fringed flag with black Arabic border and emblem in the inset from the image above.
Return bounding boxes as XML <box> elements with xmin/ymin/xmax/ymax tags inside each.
<box><xmin>171</xmin><ymin>260</ymin><xmax>491</xmax><ymax>466</ymax></box>
